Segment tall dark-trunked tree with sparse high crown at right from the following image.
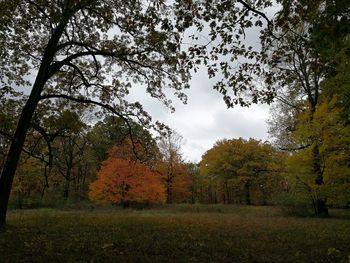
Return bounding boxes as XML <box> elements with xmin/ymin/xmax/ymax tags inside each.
<box><xmin>262</xmin><ymin>0</ymin><xmax>349</xmax><ymax>216</ymax></box>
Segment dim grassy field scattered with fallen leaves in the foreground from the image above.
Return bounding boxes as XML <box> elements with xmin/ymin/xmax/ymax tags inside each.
<box><xmin>0</xmin><ymin>205</ymin><xmax>350</xmax><ymax>262</ymax></box>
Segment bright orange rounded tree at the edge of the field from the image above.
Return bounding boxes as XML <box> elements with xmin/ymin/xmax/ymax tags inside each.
<box><xmin>89</xmin><ymin>156</ymin><xmax>165</xmax><ymax>205</ymax></box>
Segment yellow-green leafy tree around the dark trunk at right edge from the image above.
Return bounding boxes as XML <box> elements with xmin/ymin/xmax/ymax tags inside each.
<box><xmin>288</xmin><ymin>97</ymin><xmax>350</xmax><ymax>210</ymax></box>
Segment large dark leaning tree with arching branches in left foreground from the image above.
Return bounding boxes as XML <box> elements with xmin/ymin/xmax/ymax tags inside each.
<box><xmin>0</xmin><ymin>0</ymin><xmax>188</xmax><ymax>224</ymax></box>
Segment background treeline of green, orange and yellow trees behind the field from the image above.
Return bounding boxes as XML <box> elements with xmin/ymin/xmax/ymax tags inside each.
<box><xmin>2</xmin><ymin>106</ymin><xmax>350</xmax><ymax>216</ymax></box>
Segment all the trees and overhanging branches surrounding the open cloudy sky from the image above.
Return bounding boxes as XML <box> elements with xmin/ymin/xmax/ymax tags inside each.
<box><xmin>0</xmin><ymin>0</ymin><xmax>350</xmax><ymax>228</ymax></box>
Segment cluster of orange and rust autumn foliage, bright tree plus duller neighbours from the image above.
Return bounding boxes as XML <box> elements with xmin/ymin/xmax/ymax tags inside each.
<box><xmin>88</xmin><ymin>137</ymin><xmax>190</xmax><ymax>207</ymax></box>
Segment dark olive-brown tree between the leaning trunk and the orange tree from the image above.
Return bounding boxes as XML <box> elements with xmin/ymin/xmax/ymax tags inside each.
<box><xmin>22</xmin><ymin>101</ymin><xmax>94</xmax><ymax>202</ymax></box>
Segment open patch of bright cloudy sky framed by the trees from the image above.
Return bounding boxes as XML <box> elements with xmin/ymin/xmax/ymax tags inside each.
<box><xmin>130</xmin><ymin>66</ymin><xmax>269</xmax><ymax>163</ymax></box>
